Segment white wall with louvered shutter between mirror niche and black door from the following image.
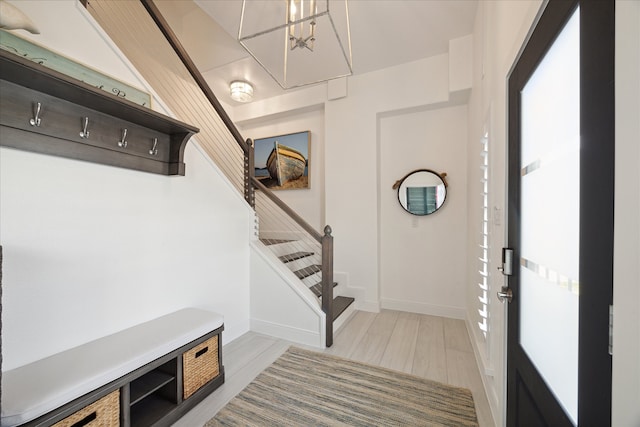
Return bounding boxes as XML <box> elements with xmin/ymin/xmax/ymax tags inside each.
<box><xmin>466</xmin><ymin>0</ymin><xmax>541</xmax><ymax>425</ymax></box>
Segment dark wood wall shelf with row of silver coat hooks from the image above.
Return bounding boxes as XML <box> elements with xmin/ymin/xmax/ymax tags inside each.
<box><xmin>0</xmin><ymin>50</ymin><xmax>199</xmax><ymax>175</ymax></box>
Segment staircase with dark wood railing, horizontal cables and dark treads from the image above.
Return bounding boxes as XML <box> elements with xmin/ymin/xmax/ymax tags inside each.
<box><xmin>80</xmin><ymin>0</ymin><xmax>354</xmax><ymax>347</ymax></box>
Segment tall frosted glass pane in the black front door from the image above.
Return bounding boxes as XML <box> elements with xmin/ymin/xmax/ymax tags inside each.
<box><xmin>520</xmin><ymin>5</ymin><xmax>580</xmax><ymax>424</ymax></box>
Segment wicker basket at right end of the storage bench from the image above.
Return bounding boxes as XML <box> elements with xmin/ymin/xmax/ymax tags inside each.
<box><xmin>182</xmin><ymin>335</ymin><xmax>220</xmax><ymax>399</ymax></box>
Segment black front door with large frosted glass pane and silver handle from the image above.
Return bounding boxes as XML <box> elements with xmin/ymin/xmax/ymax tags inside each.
<box><xmin>503</xmin><ymin>0</ymin><xmax>615</xmax><ymax>426</ymax></box>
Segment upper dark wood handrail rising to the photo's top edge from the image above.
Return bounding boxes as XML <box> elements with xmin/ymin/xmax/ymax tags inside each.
<box><xmin>140</xmin><ymin>0</ymin><xmax>249</xmax><ymax>153</ymax></box>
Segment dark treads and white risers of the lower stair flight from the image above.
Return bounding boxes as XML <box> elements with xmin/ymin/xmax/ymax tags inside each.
<box><xmin>260</xmin><ymin>239</ymin><xmax>354</xmax><ymax>320</ymax></box>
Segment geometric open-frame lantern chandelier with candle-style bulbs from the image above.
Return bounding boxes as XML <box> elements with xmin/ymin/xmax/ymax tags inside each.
<box><xmin>238</xmin><ymin>0</ymin><xmax>353</xmax><ymax>89</ymax></box>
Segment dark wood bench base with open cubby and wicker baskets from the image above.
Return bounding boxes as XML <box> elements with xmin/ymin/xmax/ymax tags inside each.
<box><xmin>12</xmin><ymin>324</ymin><xmax>224</xmax><ymax>427</ymax></box>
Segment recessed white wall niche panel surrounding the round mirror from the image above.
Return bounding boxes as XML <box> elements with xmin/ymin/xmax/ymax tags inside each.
<box><xmin>378</xmin><ymin>105</ymin><xmax>467</xmax><ymax>319</ymax></box>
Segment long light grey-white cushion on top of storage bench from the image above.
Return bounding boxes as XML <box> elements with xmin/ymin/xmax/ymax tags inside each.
<box><xmin>1</xmin><ymin>308</ymin><xmax>224</xmax><ymax>427</ymax></box>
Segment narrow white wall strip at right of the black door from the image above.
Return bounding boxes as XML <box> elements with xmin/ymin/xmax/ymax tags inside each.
<box><xmin>612</xmin><ymin>0</ymin><xmax>640</xmax><ymax>427</ymax></box>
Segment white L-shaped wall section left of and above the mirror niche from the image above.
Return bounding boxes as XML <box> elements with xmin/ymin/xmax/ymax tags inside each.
<box><xmin>325</xmin><ymin>55</ymin><xmax>456</xmax><ymax>311</ymax></box>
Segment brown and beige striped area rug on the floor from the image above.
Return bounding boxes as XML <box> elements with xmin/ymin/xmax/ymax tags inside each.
<box><xmin>205</xmin><ymin>347</ymin><xmax>478</xmax><ymax>427</ymax></box>
